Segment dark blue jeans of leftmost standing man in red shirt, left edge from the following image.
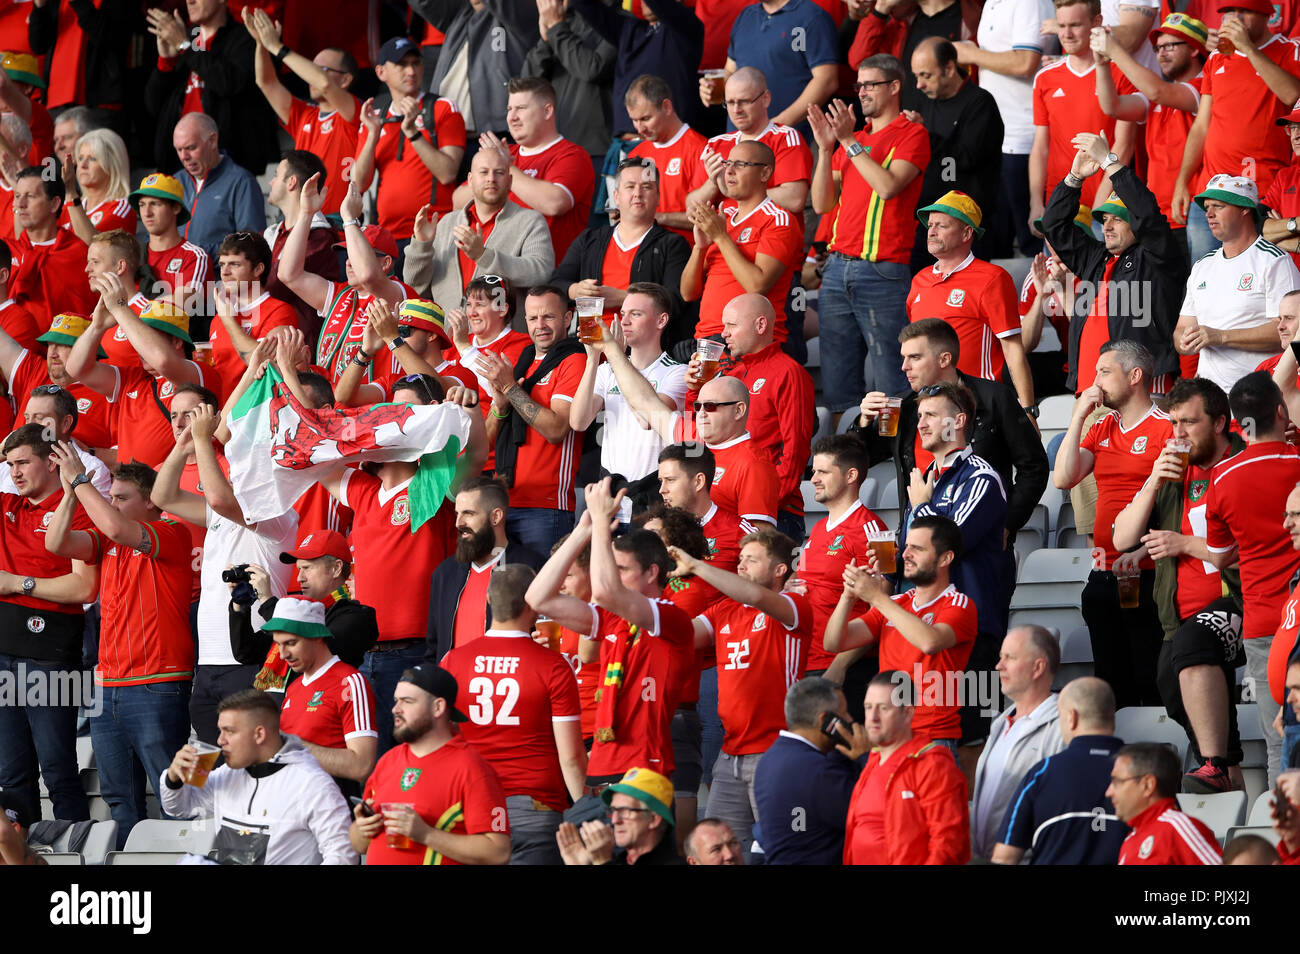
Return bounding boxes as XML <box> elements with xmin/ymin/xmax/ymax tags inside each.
<box><xmin>0</xmin><ymin>654</ymin><xmax>90</xmax><ymax>821</ymax></box>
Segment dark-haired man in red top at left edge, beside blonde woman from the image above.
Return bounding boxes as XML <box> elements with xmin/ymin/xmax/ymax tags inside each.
<box><xmin>9</xmin><ymin>166</ymin><xmax>95</xmax><ymax>322</ymax></box>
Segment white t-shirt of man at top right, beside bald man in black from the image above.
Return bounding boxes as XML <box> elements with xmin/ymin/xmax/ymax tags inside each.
<box><xmin>975</xmin><ymin>0</ymin><xmax>1056</xmax><ymax>156</ymax></box>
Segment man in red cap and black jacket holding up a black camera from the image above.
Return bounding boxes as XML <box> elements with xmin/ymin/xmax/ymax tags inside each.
<box><xmin>230</xmin><ymin>529</ymin><xmax>380</xmax><ymax>691</ymax></box>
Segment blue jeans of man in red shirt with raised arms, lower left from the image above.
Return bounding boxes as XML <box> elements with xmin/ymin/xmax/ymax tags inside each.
<box><xmin>90</xmin><ymin>682</ymin><xmax>190</xmax><ymax>851</ymax></box>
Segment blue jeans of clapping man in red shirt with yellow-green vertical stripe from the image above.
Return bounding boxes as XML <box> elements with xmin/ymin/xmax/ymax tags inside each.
<box><xmin>818</xmin><ymin>255</ymin><xmax>911</xmax><ymax>413</ymax></box>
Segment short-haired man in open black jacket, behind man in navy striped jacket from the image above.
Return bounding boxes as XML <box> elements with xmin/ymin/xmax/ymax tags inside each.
<box><xmin>850</xmin><ymin>318</ymin><xmax>1048</xmax><ymax>548</ymax></box>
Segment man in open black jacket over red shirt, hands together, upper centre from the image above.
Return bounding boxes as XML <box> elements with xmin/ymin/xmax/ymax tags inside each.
<box><xmin>551</xmin><ymin>157</ymin><xmax>696</xmax><ymax>350</ymax></box>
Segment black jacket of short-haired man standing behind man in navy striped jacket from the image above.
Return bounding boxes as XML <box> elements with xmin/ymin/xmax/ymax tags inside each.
<box><xmin>850</xmin><ymin>372</ymin><xmax>1048</xmax><ymax>534</ymax></box>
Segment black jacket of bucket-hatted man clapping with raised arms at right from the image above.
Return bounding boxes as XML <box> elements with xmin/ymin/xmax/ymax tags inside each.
<box><xmin>1043</xmin><ymin>166</ymin><xmax>1191</xmax><ymax>390</ymax></box>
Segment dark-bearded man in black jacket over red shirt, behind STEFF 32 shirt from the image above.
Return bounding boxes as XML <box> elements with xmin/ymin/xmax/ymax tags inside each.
<box><xmin>425</xmin><ymin>477</ymin><xmax>546</xmax><ymax>663</ymax></box>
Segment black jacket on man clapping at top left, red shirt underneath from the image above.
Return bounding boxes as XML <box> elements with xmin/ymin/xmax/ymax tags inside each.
<box><xmin>144</xmin><ymin>16</ymin><xmax>280</xmax><ymax>175</ymax></box>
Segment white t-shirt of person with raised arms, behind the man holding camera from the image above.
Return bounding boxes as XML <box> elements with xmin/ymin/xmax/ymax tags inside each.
<box><xmin>198</xmin><ymin>507</ymin><xmax>298</xmax><ymax>665</ymax></box>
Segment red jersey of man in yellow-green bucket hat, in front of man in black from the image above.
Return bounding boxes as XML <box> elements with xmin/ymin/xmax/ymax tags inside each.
<box><xmin>907</xmin><ymin>255</ymin><xmax>1021</xmax><ymax>381</ymax></box>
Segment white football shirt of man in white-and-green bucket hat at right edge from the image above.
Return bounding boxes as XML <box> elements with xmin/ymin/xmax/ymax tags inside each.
<box><xmin>1178</xmin><ymin>238</ymin><xmax>1300</xmax><ymax>391</ymax></box>
